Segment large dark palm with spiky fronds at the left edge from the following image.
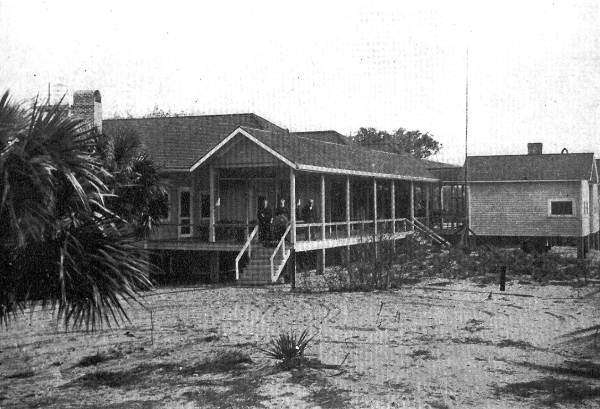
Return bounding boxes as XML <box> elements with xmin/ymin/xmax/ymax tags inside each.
<box><xmin>0</xmin><ymin>92</ymin><xmax>151</xmax><ymax>329</ymax></box>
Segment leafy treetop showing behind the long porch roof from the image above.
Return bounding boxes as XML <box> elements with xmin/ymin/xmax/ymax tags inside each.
<box><xmin>353</xmin><ymin>128</ymin><xmax>442</xmax><ymax>159</ymax></box>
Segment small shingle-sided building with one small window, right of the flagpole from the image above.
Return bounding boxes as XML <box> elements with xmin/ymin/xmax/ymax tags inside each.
<box><xmin>458</xmin><ymin>143</ymin><xmax>600</xmax><ymax>257</ymax></box>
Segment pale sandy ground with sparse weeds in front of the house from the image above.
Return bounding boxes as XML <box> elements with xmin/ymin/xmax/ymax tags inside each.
<box><xmin>0</xmin><ymin>280</ymin><xmax>600</xmax><ymax>409</ymax></box>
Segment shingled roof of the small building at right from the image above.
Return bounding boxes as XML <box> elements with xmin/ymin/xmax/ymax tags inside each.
<box><xmin>467</xmin><ymin>153</ymin><xmax>594</xmax><ymax>182</ymax></box>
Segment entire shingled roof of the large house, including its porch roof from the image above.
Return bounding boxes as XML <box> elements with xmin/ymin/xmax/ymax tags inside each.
<box><xmin>103</xmin><ymin>114</ymin><xmax>436</xmax><ymax>180</ymax></box>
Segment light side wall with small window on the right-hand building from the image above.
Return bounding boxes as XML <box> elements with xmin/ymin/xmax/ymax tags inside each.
<box><xmin>469</xmin><ymin>182</ymin><xmax>582</xmax><ymax>237</ymax></box>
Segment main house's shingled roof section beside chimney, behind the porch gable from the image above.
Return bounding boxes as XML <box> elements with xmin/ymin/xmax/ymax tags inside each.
<box><xmin>102</xmin><ymin>113</ymin><xmax>284</xmax><ymax>170</ymax></box>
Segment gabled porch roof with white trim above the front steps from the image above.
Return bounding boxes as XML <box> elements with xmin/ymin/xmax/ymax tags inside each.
<box><xmin>190</xmin><ymin>126</ymin><xmax>437</xmax><ymax>182</ymax></box>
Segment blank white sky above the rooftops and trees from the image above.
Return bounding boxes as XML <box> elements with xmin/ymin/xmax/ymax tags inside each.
<box><xmin>0</xmin><ymin>0</ymin><xmax>600</xmax><ymax>164</ymax></box>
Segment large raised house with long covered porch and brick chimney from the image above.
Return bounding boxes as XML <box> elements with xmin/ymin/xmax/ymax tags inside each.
<box><xmin>63</xmin><ymin>91</ymin><xmax>438</xmax><ymax>284</ymax></box>
